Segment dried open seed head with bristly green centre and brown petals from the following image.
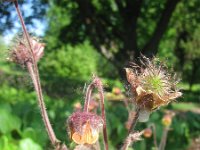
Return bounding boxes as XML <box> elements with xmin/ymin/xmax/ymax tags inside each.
<box><xmin>125</xmin><ymin>56</ymin><xmax>182</xmax><ymax>122</ymax></box>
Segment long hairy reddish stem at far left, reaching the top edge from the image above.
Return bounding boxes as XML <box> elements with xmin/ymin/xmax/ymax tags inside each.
<box><xmin>14</xmin><ymin>0</ymin><xmax>67</xmax><ymax>150</ymax></box>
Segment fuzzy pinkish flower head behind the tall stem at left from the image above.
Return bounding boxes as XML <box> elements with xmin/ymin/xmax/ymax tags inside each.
<box><xmin>8</xmin><ymin>36</ymin><xmax>45</xmax><ymax>66</ymax></box>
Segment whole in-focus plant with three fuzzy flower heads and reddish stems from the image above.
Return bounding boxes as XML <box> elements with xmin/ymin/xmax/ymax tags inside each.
<box><xmin>5</xmin><ymin>0</ymin><xmax>181</xmax><ymax>150</ymax></box>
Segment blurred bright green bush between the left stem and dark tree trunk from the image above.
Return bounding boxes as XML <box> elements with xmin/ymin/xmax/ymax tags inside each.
<box><xmin>40</xmin><ymin>41</ymin><xmax>117</xmax><ymax>96</ymax></box>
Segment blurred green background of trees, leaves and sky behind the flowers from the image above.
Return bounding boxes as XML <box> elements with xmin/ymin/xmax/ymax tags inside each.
<box><xmin>0</xmin><ymin>0</ymin><xmax>200</xmax><ymax>150</ymax></box>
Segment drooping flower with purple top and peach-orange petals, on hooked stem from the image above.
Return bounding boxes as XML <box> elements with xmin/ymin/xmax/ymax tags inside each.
<box><xmin>67</xmin><ymin>112</ymin><xmax>103</xmax><ymax>144</ymax></box>
